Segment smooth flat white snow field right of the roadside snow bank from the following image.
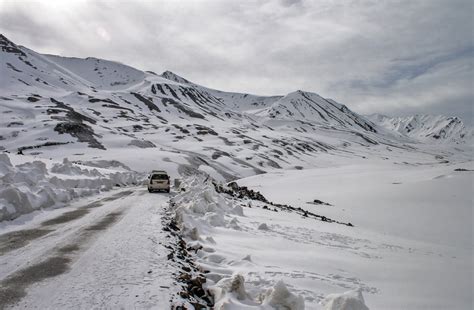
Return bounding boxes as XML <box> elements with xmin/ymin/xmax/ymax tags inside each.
<box><xmin>237</xmin><ymin>161</ymin><xmax>474</xmax><ymax>309</ymax></box>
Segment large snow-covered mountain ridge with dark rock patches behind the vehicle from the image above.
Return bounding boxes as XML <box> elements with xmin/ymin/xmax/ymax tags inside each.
<box><xmin>0</xmin><ymin>36</ymin><xmax>466</xmax><ymax>179</ymax></box>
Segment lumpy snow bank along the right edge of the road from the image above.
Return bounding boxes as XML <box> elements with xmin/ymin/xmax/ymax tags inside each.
<box><xmin>171</xmin><ymin>176</ymin><xmax>304</xmax><ymax>310</ymax></box>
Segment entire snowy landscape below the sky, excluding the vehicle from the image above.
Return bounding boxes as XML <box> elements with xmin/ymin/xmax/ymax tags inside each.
<box><xmin>0</xmin><ymin>32</ymin><xmax>474</xmax><ymax>310</ymax></box>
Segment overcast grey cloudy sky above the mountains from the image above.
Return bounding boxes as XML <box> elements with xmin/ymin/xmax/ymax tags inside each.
<box><xmin>0</xmin><ymin>0</ymin><xmax>474</xmax><ymax>123</ymax></box>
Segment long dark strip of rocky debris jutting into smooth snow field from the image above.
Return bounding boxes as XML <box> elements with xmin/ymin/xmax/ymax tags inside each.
<box><xmin>213</xmin><ymin>182</ymin><xmax>354</xmax><ymax>227</ymax></box>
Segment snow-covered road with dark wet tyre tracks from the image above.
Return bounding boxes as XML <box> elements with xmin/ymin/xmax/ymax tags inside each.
<box><xmin>0</xmin><ymin>187</ymin><xmax>175</xmax><ymax>309</ymax></box>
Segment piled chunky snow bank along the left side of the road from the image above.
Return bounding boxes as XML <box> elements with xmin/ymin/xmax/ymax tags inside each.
<box><xmin>0</xmin><ymin>154</ymin><xmax>143</xmax><ymax>221</ymax></box>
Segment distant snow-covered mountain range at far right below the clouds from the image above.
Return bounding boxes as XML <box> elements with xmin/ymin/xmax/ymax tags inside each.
<box><xmin>367</xmin><ymin>114</ymin><xmax>473</xmax><ymax>143</ymax></box>
